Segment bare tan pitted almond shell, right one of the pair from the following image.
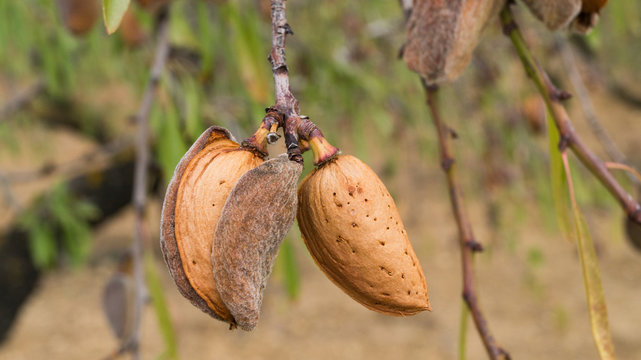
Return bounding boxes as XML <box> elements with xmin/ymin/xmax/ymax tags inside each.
<box><xmin>297</xmin><ymin>155</ymin><xmax>431</xmax><ymax>316</ymax></box>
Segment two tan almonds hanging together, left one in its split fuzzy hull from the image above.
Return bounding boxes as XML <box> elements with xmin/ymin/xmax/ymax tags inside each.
<box><xmin>161</xmin><ymin>120</ymin><xmax>429</xmax><ymax>330</ymax></box>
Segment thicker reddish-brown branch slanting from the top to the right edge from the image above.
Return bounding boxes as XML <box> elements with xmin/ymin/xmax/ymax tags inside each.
<box><xmin>500</xmin><ymin>2</ymin><xmax>641</xmax><ymax>224</ymax></box>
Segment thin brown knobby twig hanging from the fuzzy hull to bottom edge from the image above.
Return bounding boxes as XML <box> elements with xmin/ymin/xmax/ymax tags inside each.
<box><xmin>423</xmin><ymin>82</ymin><xmax>510</xmax><ymax>359</ymax></box>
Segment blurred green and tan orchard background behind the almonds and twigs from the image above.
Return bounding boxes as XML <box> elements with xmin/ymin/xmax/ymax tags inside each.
<box><xmin>0</xmin><ymin>0</ymin><xmax>641</xmax><ymax>360</ymax></box>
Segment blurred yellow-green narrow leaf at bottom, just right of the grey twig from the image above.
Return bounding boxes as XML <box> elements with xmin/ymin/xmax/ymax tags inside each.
<box><xmin>145</xmin><ymin>252</ymin><xmax>178</xmax><ymax>359</ymax></box>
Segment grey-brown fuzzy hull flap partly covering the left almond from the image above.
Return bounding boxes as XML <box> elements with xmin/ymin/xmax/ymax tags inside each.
<box><xmin>211</xmin><ymin>154</ymin><xmax>303</xmax><ymax>331</ymax></box>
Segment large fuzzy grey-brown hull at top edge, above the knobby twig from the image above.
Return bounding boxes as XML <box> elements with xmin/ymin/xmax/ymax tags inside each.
<box><xmin>403</xmin><ymin>0</ymin><xmax>505</xmax><ymax>84</ymax></box>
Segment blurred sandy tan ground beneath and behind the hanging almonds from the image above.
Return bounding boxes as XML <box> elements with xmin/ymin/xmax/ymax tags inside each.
<box><xmin>0</xmin><ymin>83</ymin><xmax>641</xmax><ymax>360</ymax></box>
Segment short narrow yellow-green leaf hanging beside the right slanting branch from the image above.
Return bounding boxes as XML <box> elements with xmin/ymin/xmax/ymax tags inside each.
<box><xmin>547</xmin><ymin>115</ymin><xmax>576</xmax><ymax>241</ymax></box>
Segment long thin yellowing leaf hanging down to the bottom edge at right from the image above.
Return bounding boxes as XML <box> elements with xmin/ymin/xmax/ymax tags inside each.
<box><xmin>562</xmin><ymin>152</ymin><xmax>615</xmax><ymax>360</ymax></box>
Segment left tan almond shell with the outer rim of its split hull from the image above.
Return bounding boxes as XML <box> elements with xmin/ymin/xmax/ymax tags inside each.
<box><xmin>161</xmin><ymin>127</ymin><xmax>263</xmax><ymax>324</ymax></box>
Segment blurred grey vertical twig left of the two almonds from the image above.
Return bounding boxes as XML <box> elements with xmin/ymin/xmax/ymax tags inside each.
<box><xmin>129</xmin><ymin>5</ymin><xmax>170</xmax><ymax>359</ymax></box>
